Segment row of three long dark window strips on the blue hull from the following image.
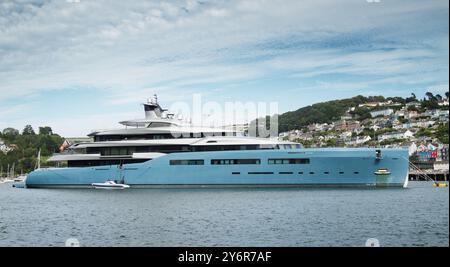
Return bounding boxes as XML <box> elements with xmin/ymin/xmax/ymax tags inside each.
<box><xmin>169</xmin><ymin>159</ymin><xmax>310</xmax><ymax>165</ymax></box>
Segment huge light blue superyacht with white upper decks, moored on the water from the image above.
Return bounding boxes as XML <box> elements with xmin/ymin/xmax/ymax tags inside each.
<box><xmin>26</xmin><ymin>97</ymin><xmax>409</xmax><ymax>188</ymax></box>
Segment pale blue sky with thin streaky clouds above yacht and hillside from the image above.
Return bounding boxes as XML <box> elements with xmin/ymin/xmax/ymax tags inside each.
<box><xmin>0</xmin><ymin>0</ymin><xmax>449</xmax><ymax>137</ymax></box>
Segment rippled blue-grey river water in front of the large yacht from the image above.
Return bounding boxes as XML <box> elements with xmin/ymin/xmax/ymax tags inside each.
<box><xmin>0</xmin><ymin>182</ymin><xmax>449</xmax><ymax>246</ymax></box>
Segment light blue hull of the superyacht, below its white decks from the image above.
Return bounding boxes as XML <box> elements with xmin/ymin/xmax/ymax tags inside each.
<box><xmin>26</xmin><ymin>148</ymin><xmax>409</xmax><ymax>188</ymax></box>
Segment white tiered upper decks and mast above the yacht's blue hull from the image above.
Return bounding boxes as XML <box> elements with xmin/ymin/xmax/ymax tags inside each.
<box><xmin>48</xmin><ymin>96</ymin><xmax>301</xmax><ymax>167</ymax></box>
